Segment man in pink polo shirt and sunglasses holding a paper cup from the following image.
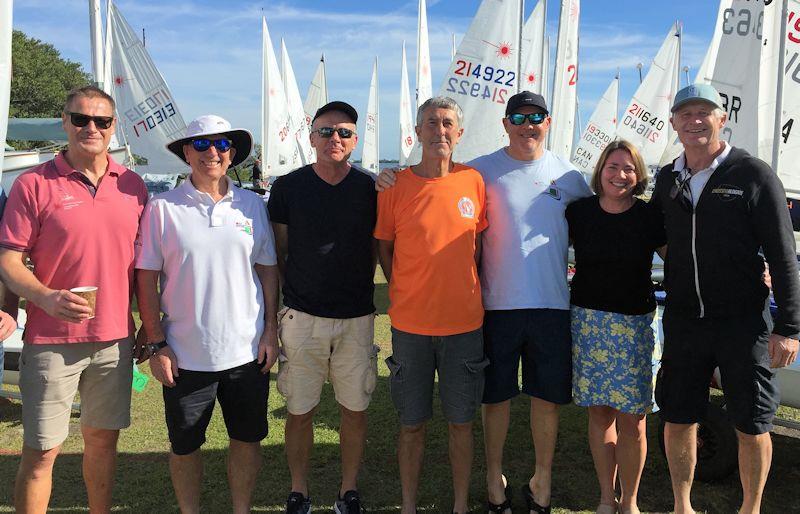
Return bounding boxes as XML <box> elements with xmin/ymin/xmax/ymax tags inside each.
<box><xmin>0</xmin><ymin>86</ymin><xmax>147</xmax><ymax>513</ymax></box>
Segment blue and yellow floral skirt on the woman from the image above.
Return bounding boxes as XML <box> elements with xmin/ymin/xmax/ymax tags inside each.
<box><xmin>571</xmin><ymin>305</ymin><xmax>655</xmax><ymax>414</ymax></box>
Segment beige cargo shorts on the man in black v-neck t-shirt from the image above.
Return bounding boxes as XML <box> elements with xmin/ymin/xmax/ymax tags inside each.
<box><xmin>277</xmin><ymin>308</ymin><xmax>378</xmax><ymax>415</ymax></box>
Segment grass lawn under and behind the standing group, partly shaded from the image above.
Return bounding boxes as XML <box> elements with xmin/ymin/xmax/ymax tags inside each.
<box><xmin>0</xmin><ymin>271</ymin><xmax>800</xmax><ymax>514</ymax></box>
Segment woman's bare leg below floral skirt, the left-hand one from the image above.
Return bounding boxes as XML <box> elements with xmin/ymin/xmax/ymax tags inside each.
<box><xmin>589</xmin><ymin>406</ymin><xmax>617</xmax><ymax>506</ymax></box>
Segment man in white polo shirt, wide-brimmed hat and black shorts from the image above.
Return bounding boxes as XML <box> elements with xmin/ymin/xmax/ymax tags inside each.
<box><xmin>136</xmin><ymin>115</ymin><xmax>278</xmax><ymax>513</ymax></box>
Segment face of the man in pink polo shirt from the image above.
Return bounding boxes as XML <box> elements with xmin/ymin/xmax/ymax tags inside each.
<box><xmin>61</xmin><ymin>96</ymin><xmax>117</xmax><ymax>158</ymax></box>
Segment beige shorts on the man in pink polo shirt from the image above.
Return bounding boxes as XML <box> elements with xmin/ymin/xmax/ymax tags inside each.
<box><xmin>19</xmin><ymin>339</ymin><xmax>133</xmax><ymax>450</ymax></box>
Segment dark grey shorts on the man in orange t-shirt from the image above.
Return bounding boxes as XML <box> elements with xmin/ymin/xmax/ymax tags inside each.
<box><xmin>386</xmin><ymin>327</ymin><xmax>489</xmax><ymax>426</ymax></box>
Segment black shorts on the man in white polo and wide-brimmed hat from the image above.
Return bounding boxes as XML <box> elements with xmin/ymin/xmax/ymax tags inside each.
<box><xmin>163</xmin><ymin>361</ymin><xmax>269</xmax><ymax>455</ymax></box>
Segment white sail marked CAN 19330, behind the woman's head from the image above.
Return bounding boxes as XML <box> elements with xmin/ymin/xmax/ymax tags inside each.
<box><xmin>572</xmin><ymin>74</ymin><xmax>619</xmax><ymax>175</ymax></box>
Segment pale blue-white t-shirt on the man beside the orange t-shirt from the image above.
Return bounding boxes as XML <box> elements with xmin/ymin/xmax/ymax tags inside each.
<box><xmin>467</xmin><ymin>148</ymin><xmax>592</xmax><ymax>310</ymax></box>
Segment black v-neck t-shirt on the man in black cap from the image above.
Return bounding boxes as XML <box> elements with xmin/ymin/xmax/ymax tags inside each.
<box><xmin>267</xmin><ymin>165</ymin><xmax>377</xmax><ymax>319</ymax></box>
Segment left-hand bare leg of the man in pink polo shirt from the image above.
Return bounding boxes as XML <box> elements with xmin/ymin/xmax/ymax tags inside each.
<box><xmin>14</xmin><ymin>445</ymin><xmax>61</xmax><ymax>514</ymax></box>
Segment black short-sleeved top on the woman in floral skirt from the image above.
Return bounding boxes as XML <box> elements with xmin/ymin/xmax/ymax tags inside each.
<box><xmin>566</xmin><ymin>196</ymin><xmax>666</xmax><ymax>314</ymax></box>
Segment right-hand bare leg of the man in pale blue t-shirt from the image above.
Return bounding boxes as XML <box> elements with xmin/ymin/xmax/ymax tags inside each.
<box><xmin>528</xmin><ymin>398</ymin><xmax>558</xmax><ymax>507</ymax></box>
